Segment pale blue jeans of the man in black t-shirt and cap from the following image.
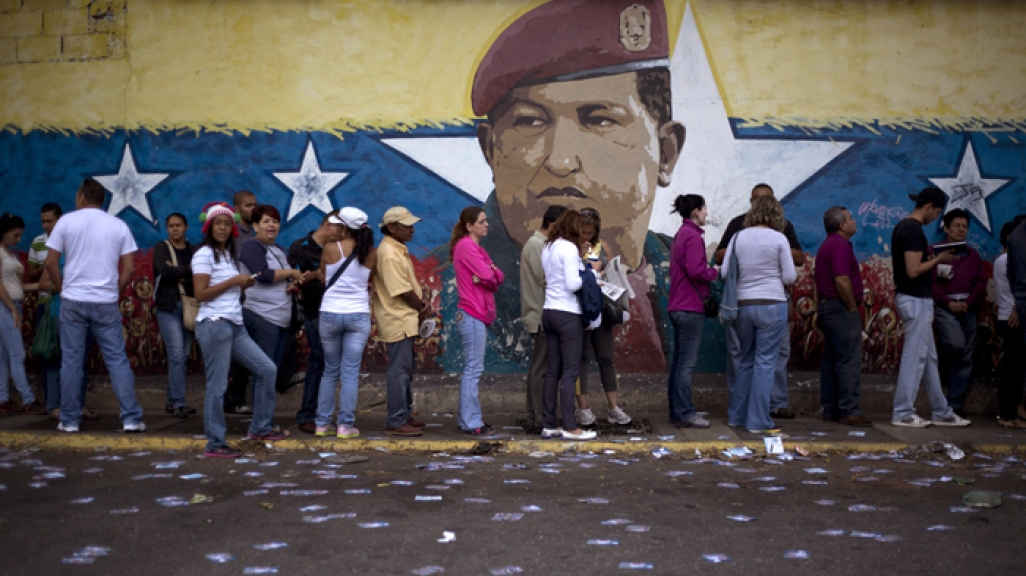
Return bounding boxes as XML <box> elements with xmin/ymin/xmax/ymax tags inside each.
<box><xmin>892</xmin><ymin>294</ymin><xmax>951</xmax><ymax>420</ymax></box>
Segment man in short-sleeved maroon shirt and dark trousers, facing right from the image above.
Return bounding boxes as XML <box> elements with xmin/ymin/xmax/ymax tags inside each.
<box><xmin>816</xmin><ymin>206</ymin><xmax>873</xmax><ymax>426</ymax></box>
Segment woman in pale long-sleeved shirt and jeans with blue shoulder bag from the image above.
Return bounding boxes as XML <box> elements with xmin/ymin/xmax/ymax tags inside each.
<box><xmin>722</xmin><ymin>196</ymin><xmax>797</xmax><ymax>433</ymax></box>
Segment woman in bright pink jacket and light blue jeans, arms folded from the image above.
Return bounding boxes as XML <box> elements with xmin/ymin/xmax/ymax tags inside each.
<box><xmin>449</xmin><ymin>206</ymin><xmax>505</xmax><ymax>435</ymax></box>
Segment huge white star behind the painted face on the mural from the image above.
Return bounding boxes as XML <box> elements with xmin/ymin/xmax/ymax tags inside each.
<box><xmin>382</xmin><ymin>1</ymin><xmax>852</xmax><ymax>242</ymax></box>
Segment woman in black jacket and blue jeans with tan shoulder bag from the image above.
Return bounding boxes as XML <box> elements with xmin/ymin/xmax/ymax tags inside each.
<box><xmin>153</xmin><ymin>213</ymin><xmax>196</xmax><ymax>418</ymax></box>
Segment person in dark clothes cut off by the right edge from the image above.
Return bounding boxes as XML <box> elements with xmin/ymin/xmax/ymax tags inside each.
<box><xmin>994</xmin><ymin>218</ymin><xmax>1026</xmax><ymax>428</ymax></box>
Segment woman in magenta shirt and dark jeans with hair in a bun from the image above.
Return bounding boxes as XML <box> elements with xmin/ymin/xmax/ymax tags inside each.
<box><xmin>667</xmin><ymin>194</ymin><xmax>719</xmax><ymax>428</ymax></box>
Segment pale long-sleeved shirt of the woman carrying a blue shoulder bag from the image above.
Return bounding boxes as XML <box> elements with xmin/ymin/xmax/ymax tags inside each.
<box><xmin>720</xmin><ymin>228</ymin><xmax>798</xmax><ymax>302</ymax></box>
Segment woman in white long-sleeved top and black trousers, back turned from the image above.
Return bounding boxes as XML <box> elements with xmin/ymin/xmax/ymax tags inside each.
<box><xmin>542</xmin><ymin>210</ymin><xmax>595</xmax><ymax>440</ymax></box>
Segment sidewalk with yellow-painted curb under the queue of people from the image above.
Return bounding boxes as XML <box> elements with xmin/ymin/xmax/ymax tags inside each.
<box><xmin>0</xmin><ymin>410</ymin><xmax>1026</xmax><ymax>456</ymax></box>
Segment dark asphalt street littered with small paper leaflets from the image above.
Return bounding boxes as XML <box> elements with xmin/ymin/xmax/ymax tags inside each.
<box><xmin>0</xmin><ymin>444</ymin><xmax>1026</xmax><ymax>576</ymax></box>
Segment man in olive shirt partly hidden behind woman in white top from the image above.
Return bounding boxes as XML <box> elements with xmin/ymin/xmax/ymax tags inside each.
<box><xmin>520</xmin><ymin>206</ymin><xmax>566</xmax><ymax>427</ymax></box>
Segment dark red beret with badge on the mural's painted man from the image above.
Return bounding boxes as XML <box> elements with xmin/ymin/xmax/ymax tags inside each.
<box><xmin>471</xmin><ymin>0</ymin><xmax>670</xmax><ymax>116</ymax></box>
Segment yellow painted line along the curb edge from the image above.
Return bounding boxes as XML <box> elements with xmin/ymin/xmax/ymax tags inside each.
<box><xmin>0</xmin><ymin>431</ymin><xmax>1026</xmax><ymax>456</ymax></box>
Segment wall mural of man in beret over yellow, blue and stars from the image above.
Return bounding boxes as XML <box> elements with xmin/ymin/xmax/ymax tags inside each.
<box><xmin>0</xmin><ymin>0</ymin><xmax>1026</xmax><ymax>374</ymax></box>
